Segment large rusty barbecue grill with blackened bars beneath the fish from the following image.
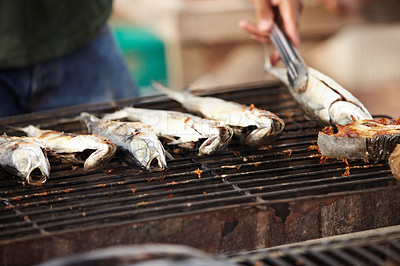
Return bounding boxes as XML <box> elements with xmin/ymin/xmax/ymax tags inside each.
<box><xmin>0</xmin><ymin>83</ymin><xmax>400</xmax><ymax>261</ymax></box>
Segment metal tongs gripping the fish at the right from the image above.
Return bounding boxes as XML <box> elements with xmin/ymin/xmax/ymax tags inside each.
<box><xmin>271</xmin><ymin>22</ymin><xmax>308</xmax><ymax>92</ymax></box>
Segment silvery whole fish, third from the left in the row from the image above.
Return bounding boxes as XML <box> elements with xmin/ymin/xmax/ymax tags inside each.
<box><xmin>80</xmin><ymin>112</ymin><xmax>167</xmax><ymax>170</ymax></box>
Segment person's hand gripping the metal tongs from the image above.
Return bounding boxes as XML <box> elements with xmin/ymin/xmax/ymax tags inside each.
<box><xmin>238</xmin><ymin>0</ymin><xmax>303</xmax><ymax>65</ymax></box>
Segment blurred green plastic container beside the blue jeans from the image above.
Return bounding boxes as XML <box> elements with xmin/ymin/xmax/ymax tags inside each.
<box><xmin>112</xmin><ymin>25</ymin><xmax>168</xmax><ymax>96</ymax></box>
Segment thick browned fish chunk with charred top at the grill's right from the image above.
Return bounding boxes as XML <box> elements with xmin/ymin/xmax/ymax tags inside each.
<box><xmin>317</xmin><ymin>119</ymin><xmax>400</xmax><ymax>162</ymax></box>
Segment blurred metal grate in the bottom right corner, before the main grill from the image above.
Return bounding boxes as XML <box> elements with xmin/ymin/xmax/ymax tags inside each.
<box><xmin>230</xmin><ymin>226</ymin><xmax>400</xmax><ymax>266</ymax></box>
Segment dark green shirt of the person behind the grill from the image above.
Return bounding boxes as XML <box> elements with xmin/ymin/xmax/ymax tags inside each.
<box><xmin>0</xmin><ymin>0</ymin><xmax>112</xmax><ymax>68</ymax></box>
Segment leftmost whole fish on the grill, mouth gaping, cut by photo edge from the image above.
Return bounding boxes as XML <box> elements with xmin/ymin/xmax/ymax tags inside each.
<box><xmin>0</xmin><ymin>135</ymin><xmax>50</xmax><ymax>185</ymax></box>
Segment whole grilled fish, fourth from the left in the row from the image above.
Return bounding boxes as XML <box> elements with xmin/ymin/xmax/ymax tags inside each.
<box><xmin>102</xmin><ymin>107</ymin><xmax>233</xmax><ymax>155</ymax></box>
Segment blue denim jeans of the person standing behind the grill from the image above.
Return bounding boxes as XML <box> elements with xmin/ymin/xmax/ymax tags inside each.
<box><xmin>0</xmin><ymin>26</ymin><xmax>138</xmax><ymax>116</ymax></box>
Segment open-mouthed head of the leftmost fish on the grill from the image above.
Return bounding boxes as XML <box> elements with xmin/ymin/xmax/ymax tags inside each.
<box><xmin>12</xmin><ymin>145</ymin><xmax>50</xmax><ymax>185</ymax></box>
